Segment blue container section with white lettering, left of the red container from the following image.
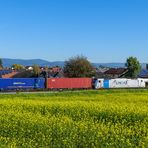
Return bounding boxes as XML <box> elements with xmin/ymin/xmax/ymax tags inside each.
<box><xmin>0</xmin><ymin>78</ymin><xmax>45</xmax><ymax>90</ymax></box>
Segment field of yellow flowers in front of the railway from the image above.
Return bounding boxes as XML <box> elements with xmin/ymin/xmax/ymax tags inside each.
<box><xmin>0</xmin><ymin>90</ymin><xmax>148</xmax><ymax>148</ymax></box>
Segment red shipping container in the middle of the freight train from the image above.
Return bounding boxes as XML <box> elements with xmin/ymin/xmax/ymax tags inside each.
<box><xmin>47</xmin><ymin>78</ymin><xmax>92</xmax><ymax>89</ymax></box>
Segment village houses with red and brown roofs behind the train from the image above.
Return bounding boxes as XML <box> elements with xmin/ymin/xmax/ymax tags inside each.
<box><xmin>0</xmin><ymin>64</ymin><xmax>148</xmax><ymax>79</ymax></box>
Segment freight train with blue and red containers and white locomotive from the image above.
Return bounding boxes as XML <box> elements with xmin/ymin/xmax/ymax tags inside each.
<box><xmin>0</xmin><ymin>78</ymin><xmax>148</xmax><ymax>91</ymax></box>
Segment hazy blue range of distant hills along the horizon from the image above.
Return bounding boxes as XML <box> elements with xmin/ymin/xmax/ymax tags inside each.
<box><xmin>2</xmin><ymin>58</ymin><xmax>146</xmax><ymax>68</ymax></box>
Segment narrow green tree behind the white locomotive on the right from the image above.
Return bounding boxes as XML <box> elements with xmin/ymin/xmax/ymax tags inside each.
<box><xmin>125</xmin><ymin>57</ymin><xmax>141</xmax><ymax>78</ymax></box>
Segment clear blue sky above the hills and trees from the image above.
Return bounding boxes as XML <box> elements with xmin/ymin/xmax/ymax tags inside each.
<box><xmin>0</xmin><ymin>0</ymin><xmax>148</xmax><ymax>62</ymax></box>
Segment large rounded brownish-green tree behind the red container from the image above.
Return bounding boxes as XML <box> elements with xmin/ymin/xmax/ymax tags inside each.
<box><xmin>64</xmin><ymin>56</ymin><xmax>93</xmax><ymax>78</ymax></box>
